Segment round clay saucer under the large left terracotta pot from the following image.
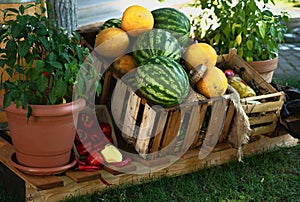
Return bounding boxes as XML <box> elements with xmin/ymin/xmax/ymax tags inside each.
<box><xmin>10</xmin><ymin>153</ymin><xmax>77</xmax><ymax>175</ymax></box>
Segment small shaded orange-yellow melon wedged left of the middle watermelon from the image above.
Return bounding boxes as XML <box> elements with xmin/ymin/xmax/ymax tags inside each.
<box><xmin>113</xmin><ymin>55</ymin><xmax>136</xmax><ymax>74</ymax></box>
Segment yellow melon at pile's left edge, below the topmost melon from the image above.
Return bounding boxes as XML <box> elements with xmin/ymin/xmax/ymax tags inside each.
<box><xmin>95</xmin><ymin>27</ymin><xmax>129</xmax><ymax>58</ymax></box>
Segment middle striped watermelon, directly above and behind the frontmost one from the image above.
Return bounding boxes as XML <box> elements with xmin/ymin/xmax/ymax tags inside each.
<box><xmin>133</xmin><ymin>29</ymin><xmax>181</xmax><ymax>65</ymax></box>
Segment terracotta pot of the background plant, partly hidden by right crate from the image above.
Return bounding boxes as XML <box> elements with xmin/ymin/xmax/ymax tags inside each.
<box><xmin>248</xmin><ymin>56</ymin><xmax>278</xmax><ymax>83</ymax></box>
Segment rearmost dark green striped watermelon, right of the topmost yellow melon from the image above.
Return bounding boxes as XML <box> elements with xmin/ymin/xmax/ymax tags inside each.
<box><xmin>151</xmin><ymin>7</ymin><xmax>191</xmax><ymax>46</ymax></box>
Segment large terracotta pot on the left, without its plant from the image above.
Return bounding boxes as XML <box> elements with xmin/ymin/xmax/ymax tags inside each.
<box><xmin>6</xmin><ymin>99</ymin><xmax>86</xmax><ymax>168</ymax></box>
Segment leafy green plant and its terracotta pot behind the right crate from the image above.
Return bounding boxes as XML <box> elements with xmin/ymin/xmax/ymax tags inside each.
<box><xmin>190</xmin><ymin>0</ymin><xmax>289</xmax><ymax>82</ymax></box>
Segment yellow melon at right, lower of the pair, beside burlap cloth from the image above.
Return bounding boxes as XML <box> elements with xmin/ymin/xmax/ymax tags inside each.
<box><xmin>196</xmin><ymin>67</ymin><xmax>228</xmax><ymax>98</ymax></box>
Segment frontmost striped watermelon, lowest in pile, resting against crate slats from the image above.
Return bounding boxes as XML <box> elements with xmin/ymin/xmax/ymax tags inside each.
<box><xmin>135</xmin><ymin>56</ymin><xmax>189</xmax><ymax>107</ymax></box>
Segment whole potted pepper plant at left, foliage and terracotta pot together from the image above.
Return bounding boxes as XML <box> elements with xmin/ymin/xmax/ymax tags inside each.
<box><xmin>0</xmin><ymin>3</ymin><xmax>101</xmax><ymax>168</ymax></box>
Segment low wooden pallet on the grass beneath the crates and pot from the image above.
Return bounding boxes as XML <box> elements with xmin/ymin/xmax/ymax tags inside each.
<box><xmin>0</xmin><ymin>130</ymin><xmax>298</xmax><ymax>202</ymax></box>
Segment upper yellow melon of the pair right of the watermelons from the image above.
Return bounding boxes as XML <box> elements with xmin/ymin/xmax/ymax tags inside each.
<box><xmin>184</xmin><ymin>43</ymin><xmax>218</xmax><ymax>70</ymax></box>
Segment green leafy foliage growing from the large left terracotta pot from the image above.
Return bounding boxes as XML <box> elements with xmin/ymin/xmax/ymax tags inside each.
<box><xmin>0</xmin><ymin>3</ymin><xmax>101</xmax><ymax>115</ymax></box>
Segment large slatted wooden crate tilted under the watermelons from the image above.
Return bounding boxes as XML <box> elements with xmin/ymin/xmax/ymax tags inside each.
<box><xmin>100</xmin><ymin>68</ymin><xmax>234</xmax><ymax>159</ymax></box>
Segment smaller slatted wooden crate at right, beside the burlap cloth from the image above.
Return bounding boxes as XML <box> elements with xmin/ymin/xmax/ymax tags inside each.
<box><xmin>218</xmin><ymin>49</ymin><xmax>284</xmax><ymax>136</ymax></box>
